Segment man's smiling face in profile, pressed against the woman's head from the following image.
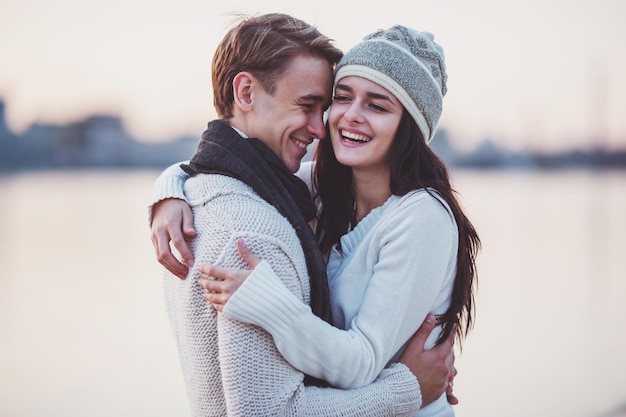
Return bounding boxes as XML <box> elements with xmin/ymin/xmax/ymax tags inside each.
<box><xmin>246</xmin><ymin>56</ymin><xmax>332</xmax><ymax>172</ymax></box>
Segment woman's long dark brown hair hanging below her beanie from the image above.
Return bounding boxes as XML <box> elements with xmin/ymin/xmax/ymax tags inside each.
<box><xmin>313</xmin><ymin>110</ymin><xmax>480</xmax><ymax>343</ymax></box>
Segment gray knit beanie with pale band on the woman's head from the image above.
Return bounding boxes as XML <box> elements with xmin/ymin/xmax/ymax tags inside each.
<box><xmin>335</xmin><ymin>25</ymin><xmax>448</xmax><ymax>143</ymax></box>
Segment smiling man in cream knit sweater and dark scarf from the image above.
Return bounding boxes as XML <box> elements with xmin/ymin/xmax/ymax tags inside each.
<box><xmin>152</xmin><ymin>14</ymin><xmax>451</xmax><ymax>416</ymax></box>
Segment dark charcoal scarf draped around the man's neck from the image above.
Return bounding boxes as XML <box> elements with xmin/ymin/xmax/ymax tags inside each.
<box><xmin>182</xmin><ymin>120</ymin><xmax>331</xmax><ymax>323</ymax></box>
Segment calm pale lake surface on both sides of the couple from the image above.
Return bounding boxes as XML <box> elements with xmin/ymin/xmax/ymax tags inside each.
<box><xmin>0</xmin><ymin>167</ymin><xmax>626</xmax><ymax>417</ymax></box>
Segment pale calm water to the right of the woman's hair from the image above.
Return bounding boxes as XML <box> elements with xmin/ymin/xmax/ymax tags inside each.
<box><xmin>448</xmin><ymin>172</ymin><xmax>626</xmax><ymax>417</ymax></box>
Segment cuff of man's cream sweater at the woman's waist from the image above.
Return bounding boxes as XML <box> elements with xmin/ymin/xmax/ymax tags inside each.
<box><xmin>378</xmin><ymin>363</ymin><xmax>422</xmax><ymax>415</ymax></box>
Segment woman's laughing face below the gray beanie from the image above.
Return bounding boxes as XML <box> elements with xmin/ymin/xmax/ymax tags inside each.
<box><xmin>328</xmin><ymin>76</ymin><xmax>403</xmax><ymax>171</ymax></box>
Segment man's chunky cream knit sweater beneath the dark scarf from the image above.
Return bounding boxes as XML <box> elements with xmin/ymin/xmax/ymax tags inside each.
<box><xmin>155</xmin><ymin>169</ymin><xmax>421</xmax><ymax>417</ymax></box>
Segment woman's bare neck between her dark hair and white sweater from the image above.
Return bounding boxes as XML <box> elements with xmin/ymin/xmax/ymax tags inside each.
<box><xmin>352</xmin><ymin>169</ymin><xmax>391</xmax><ymax>223</ymax></box>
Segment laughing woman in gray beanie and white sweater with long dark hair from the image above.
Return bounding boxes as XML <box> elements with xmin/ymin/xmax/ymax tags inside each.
<box><xmin>151</xmin><ymin>26</ymin><xmax>480</xmax><ymax>416</ymax></box>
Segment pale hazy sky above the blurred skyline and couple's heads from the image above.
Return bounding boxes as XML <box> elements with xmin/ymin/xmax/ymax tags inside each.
<box><xmin>0</xmin><ymin>0</ymin><xmax>626</xmax><ymax>150</ymax></box>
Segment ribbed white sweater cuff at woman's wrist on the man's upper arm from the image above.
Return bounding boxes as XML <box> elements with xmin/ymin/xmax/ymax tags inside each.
<box><xmin>223</xmin><ymin>261</ymin><xmax>310</xmax><ymax>334</ymax></box>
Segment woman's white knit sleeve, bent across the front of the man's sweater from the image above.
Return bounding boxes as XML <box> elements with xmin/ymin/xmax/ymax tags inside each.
<box><xmin>210</xmin><ymin>191</ymin><xmax>456</xmax><ymax>388</ymax></box>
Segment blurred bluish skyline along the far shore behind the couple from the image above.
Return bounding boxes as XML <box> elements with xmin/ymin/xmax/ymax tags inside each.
<box><xmin>0</xmin><ymin>100</ymin><xmax>626</xmax><ymax>171</ymax></box>
